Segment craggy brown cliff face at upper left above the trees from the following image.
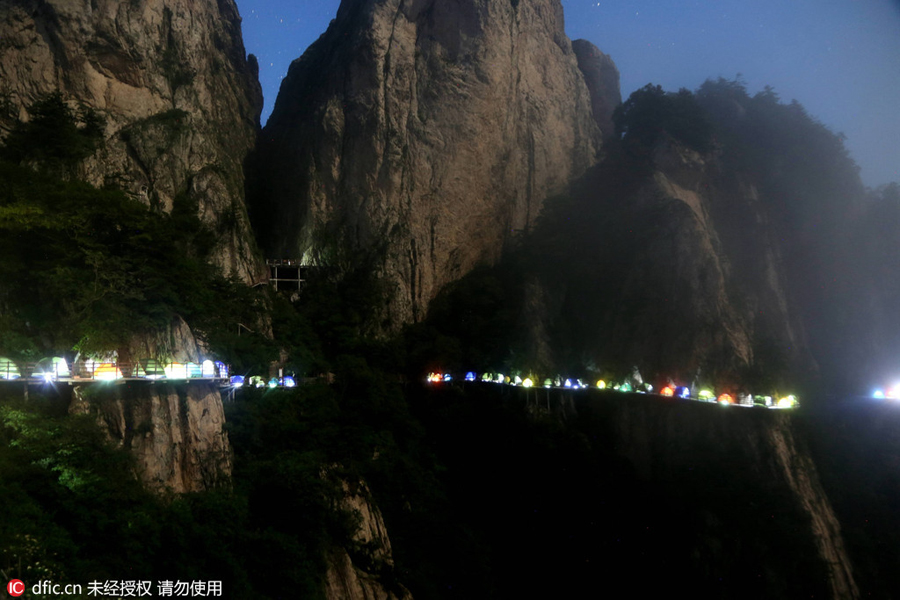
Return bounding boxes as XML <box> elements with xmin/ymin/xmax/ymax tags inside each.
<box><xmin>0</xmin><ymin>0</ymin><xmax>263</xmax><ymax>282</ymax></box>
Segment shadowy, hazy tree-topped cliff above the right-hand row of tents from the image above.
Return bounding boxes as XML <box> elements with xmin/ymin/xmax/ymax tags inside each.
<box><xmin>522</xmin><ymin>138</ymin><xmax>815</xmax><ymax>389</ymax></box>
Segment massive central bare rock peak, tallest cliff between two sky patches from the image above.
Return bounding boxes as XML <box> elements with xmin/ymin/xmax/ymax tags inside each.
<box><xmin>253</xmin><ymin>0</ymin><xmax>601</xmax><ymax>325</ymax></box>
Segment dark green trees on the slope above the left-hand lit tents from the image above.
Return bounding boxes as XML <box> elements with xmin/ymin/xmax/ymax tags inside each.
<box><xmin>0</xmin><ymin>95</ymin><xmax>277</xmax><ymax>368</ymax></box>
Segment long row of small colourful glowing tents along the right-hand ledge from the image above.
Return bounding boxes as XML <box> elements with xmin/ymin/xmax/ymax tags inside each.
<box><xmin>425</xmin><ymin>371</ymin><xmax>799</xmax><ymax>408</ymax></box>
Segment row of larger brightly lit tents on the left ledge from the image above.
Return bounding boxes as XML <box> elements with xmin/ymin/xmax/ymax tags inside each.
<box><xmin>0</xmin><ymin>356</ymin><xmax>229</xmax><ymax>382</ymax></box>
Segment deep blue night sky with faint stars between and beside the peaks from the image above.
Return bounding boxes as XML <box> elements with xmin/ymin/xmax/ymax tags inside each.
<box><xmin>237</xmin><ymin>0</ymin><xmax>900</xmax><ymax>186</ymax></box>
